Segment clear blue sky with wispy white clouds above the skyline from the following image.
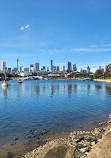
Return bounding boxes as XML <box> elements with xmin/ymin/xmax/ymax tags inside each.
<box><xmin>0</xmin><ymin>0</ymin><xmax>111</xmax><ymax>70</ymax></box>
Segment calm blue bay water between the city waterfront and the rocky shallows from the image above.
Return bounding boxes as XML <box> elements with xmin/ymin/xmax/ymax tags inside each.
<box><xmin>0</xmin><ymin>80</ymin><xmax>111</xmax><ymax>157</ymax></box>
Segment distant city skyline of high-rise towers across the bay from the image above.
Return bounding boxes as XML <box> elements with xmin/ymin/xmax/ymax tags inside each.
<box><xmin>1</xmin><ymin>58</ymin><xmax>107</xmax><ymax>73</ymax></box>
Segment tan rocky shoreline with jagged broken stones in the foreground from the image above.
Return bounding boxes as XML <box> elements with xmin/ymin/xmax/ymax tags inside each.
<box><xmin>21</xmin><ymin>115</ymin><xmax>111</xmax><ymax>158</ymax></box>
